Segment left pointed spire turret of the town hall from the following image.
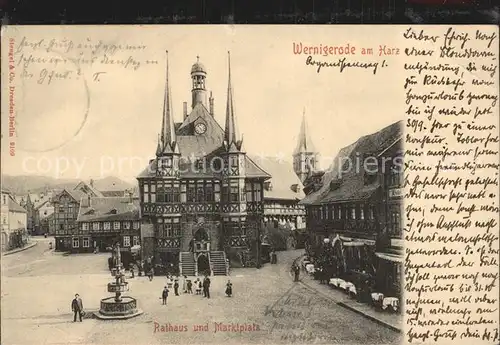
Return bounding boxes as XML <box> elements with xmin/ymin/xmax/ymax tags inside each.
<box><xmin>156</xmin><ymin>51</ymin><xmax>180</xmax><ymax>178</ymax></box>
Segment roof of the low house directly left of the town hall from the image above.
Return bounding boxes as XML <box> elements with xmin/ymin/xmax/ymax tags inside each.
<box><xmin>77</xmin><ymin>197</ymin><xmax>140</xmax><ymax>222</ymax></box>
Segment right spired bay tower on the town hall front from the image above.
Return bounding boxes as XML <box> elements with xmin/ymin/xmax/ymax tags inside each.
<box><xmin>221</xmin><ymin>52</ymin><xmax>247</xmax><ymax>239</ymax></box>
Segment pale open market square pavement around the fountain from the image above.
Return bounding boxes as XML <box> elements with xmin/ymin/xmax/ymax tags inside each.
<box><xmin>2</xmin><ymin>246</ymin><xmax>399</xmax><ymax>345</ymax></box>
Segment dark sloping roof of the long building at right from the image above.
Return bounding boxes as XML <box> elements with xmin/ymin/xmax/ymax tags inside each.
<box><xmin>300</xmin><ymin>121</ymin><xmax>403</xmax><ymax>205</ymax></box>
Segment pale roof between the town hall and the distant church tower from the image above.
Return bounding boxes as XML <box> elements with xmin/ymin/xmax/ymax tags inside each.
<box><xmin>252</xmin><ymin>157</ymin><xmax>304</xmax><ymax>200</ymax></box>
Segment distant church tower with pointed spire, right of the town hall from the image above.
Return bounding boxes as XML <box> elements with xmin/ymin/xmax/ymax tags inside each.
<box><xmin>293</xmin><ymin>109</ymin><xmax>318</xmax><ymax>182</ymax></box>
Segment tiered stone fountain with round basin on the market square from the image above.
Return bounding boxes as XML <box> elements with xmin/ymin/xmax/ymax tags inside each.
<box><xmin>95</xmin><ymin>244</ymin><xmax>143</xmax><ymax>320</ymax></box>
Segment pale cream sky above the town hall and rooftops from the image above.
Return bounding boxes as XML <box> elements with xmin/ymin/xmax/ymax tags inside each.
<box><xmin>2</xmin><ymin>26</ymin><xmax>404</xmax><ymax>181</ymax></box>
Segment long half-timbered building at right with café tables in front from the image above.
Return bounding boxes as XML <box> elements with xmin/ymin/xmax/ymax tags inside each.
<box><xmin>300</xmin><ymin>122</ymin><xmax>403</xmax><ymax>296</ymax></box>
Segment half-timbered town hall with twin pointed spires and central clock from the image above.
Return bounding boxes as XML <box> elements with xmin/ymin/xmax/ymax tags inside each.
<box><xmin>137</xmin><ymin>53</ymin><xmax>305</xmax><ymax>275</ymax></box>
